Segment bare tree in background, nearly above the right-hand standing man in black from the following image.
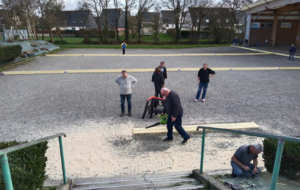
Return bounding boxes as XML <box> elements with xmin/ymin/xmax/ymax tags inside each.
<box><xmin>189</xmin><ymin>0</ymin><xmax>212</xmax><ymax>41</ymax></box>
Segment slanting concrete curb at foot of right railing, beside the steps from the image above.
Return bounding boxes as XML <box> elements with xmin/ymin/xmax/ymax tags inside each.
<box><xmin>193</xmin><ymin>170</ymin><xmax>228</xmax><ymax>190</ymax></box>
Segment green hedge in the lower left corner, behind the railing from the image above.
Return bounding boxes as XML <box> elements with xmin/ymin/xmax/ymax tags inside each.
<box><xmin>0</xmin><ymin>141</ymin><xmax>48</xmax><ymax>190</ymax></box>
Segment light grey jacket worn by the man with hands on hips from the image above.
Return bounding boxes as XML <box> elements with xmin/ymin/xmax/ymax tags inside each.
<box><xmin>115</xmin><ymin>75</ymin><xmax>137</xmax><ymax>95</ymax></box>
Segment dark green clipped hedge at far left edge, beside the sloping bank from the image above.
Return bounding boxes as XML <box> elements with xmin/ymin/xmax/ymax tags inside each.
<box><xmin>0</xmin><ymin>45</ymin><xmax>22</xmax><ymax>63</ymax></box>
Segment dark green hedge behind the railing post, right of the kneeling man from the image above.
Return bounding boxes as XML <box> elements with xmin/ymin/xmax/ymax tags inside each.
<box><xmin>262</xmin><ymin>139</ymin><xmax>300</xmax><ymax>179</ymax></box>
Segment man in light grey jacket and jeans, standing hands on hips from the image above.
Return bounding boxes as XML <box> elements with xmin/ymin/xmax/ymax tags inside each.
<box><xmin>115</xmin><ymin>70</ymin><xmax>137</xmax><ymax>117</ymax></box>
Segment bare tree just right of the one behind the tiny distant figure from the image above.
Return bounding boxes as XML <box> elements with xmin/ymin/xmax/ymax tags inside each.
<box><xmin>137</xmin><ymin>0</ymin><xmax>155</xmax><ymax>41</ymax></box>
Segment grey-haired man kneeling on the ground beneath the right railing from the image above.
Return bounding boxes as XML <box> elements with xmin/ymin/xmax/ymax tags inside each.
<box><xmin>231</xmin><ymin>143</ymin><xmax>263</xmax><ymax>177</ymax></box>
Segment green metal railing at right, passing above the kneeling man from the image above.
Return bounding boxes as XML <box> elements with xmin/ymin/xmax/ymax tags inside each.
<box><xmin>197</xmin><ymin>126</ymin><xmax>300</xmax><ymax>190</ymax></box>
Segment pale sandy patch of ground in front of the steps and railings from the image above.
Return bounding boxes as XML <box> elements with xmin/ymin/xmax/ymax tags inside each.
<box><xmin>47</xmin><ymin>119</ymin><xmax>263</xmax><ymax>179</ymax></box>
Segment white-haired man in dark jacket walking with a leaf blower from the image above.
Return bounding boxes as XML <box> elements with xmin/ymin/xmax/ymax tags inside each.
<box><xmin>161</xmin><ymin>88</ymin><xmax>191</xmax><ymax>144</ymax></box>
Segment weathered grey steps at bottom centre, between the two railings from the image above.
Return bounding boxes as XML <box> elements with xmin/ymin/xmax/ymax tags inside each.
<box><xmin>72</xmin><ymin>173</ymin><xmax>203</xmax><ymax>190</ymax></box>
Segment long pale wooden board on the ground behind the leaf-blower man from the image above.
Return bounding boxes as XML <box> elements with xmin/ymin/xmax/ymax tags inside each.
<box><xmin>132</xmin><ymin>122</ymin><xmax>259</xmax><ymax>135</ymax></box>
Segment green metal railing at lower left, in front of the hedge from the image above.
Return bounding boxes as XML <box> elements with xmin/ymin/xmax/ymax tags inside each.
<box><xmin>0</xmin><ymin>133</ymin><xmax>67</xmax><ymax>190</ymax></box>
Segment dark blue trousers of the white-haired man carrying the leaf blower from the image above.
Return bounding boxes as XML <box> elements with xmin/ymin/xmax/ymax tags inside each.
<box><xmin>167</xmin><ymin>115</ymin><xmax>190</xmax><ymax>139</ymax></box>
